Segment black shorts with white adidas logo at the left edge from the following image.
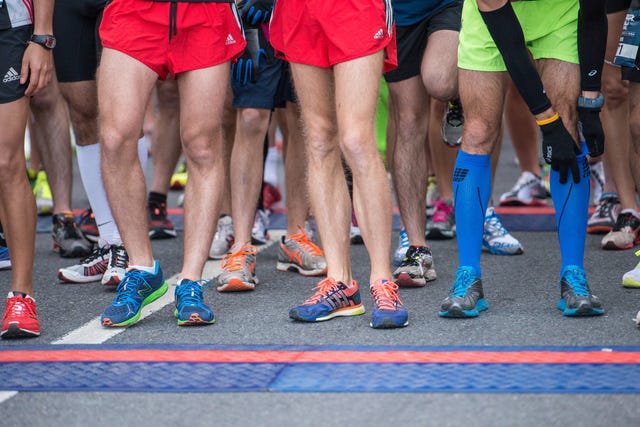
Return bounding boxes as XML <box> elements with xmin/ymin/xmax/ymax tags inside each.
<box><xmin>0</xmin><ymin>25</ymin><xmax>33</xmax><ymax>104</ymax></box>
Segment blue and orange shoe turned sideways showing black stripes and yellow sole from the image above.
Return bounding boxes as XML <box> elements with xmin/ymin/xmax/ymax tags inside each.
<box><xmin>289</xmin><ymin>277</ymin><xmax>364</xmax><ymax>322</ymax></box>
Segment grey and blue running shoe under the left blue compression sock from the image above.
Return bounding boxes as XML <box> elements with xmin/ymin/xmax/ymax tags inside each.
<box><xmin>438</xmin><ymin>267</ymin><xmax>489</xmax><ymax>317</ymax></box>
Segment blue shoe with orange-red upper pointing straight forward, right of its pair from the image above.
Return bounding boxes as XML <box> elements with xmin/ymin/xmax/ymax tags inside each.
<box><xmin>370</xmin><ymin>279</ymin><xmax>409</xmax><ymax>329</ymax></box>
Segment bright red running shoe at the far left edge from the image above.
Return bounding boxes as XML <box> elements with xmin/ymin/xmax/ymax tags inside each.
<box><xmin>0</xmin><ymin>292</ymin><xmax>40</xmax><ymax>338</ymax></box>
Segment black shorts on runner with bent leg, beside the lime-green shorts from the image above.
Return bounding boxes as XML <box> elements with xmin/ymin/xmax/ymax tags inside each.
<box><xmin>384</xmin><ymin>2</ymin><xmax>462</xmax><ymax>83</ymax></box>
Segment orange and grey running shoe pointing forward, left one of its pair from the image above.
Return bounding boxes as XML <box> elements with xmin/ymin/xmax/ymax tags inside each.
<box><xmin>218</xmin><ymin>242</ymin><xmax>258</xmax><ymax>292</ymax></box>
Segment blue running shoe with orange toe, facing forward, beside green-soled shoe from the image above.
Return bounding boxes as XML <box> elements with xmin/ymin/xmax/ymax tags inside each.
<box><xmin>173</xmin><ymin>279</ymin><xmax>216</xmax><ymax>326</ymax></box>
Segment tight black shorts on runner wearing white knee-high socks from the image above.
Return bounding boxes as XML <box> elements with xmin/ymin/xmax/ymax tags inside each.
<box><xmin>53</xmin><ymin>0</ymin><xmax>107</xmax><ymax>83</ymax></box>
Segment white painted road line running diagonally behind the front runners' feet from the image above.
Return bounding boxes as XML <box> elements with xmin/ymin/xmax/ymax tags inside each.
<box><xmin>51</xmin><ymin>234</ymin><xmax>286</xmax><ymax>344</ymax></box>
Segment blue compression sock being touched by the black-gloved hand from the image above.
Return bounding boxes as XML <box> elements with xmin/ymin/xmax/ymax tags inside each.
<box><xmin>549</xmin><ymin>143</ymin><xmax>590</xmax><ymax>271</ymax></box>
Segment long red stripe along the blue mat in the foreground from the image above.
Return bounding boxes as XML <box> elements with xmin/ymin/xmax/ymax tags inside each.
<box><xmin>0</xmin><ymin>350</ymin><xmax>640</xmax><ymax>364</ymax></box>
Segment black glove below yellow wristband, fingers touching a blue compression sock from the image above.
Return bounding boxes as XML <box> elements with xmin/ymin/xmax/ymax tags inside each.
<box><xmin>540</xmin><ymin>117</ymin><xmax>580</xmax><ymax>184</ymax></box>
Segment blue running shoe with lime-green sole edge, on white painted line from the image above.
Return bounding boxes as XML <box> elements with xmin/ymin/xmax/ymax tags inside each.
<box><xmin>101</xmin><ymin>261</ymin><xmax>169</xmax><ymax>326</ymax></box>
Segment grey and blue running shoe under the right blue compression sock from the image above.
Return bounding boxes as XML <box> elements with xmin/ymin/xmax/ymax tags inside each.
<box><xmin>558</xmin><ymin>265</ymin><xmax>604</xmax><ymax>316</ymax></box>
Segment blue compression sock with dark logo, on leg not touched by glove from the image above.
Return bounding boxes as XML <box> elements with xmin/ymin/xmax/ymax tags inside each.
<box><xmin>453</xmin><ymin>150</ymin><xmax>491</xmax><ymax>277</ymax></box>
